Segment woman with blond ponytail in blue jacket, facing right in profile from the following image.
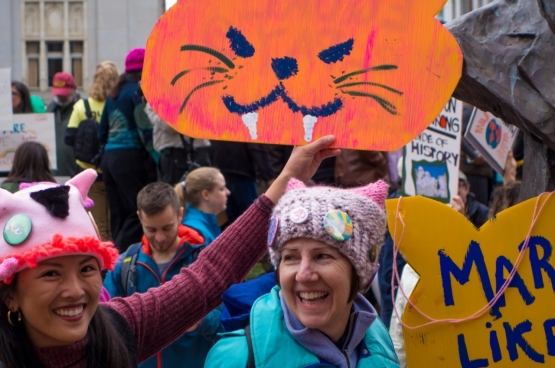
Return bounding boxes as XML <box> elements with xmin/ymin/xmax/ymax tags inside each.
<box><xmin>175</xmin><ymin>167</ymin><xmax>230</xmax><ymax>245</ymax></box>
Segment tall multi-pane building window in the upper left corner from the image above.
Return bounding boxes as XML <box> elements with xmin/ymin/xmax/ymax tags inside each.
<box><xmin>22</xmin><ymin>0</ymin><xmax>87</xmax><ymax>91</ymax></box>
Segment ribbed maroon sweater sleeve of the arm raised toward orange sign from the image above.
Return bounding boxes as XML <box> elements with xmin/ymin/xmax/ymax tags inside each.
<box><xmin>105</xmin><ymin>195</ymin><xmax>274</xmax><ymax>362</ymax></box>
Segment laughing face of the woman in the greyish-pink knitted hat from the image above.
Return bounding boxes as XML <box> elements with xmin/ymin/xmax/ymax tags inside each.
<box><xmin>279</xmin><ymin>238</ymin><xmax>353</xmax><ymax>341</ymax></box>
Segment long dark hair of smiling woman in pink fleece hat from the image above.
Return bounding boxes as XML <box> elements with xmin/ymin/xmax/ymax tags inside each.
<box><xmin>0</xmin><ymin>274</ymin><xmax>136</xmax><ymax>368</ymax></box>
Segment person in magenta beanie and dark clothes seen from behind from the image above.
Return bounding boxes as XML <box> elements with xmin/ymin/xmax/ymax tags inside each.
<box><xmin>98</xmin><ymin>48</ymin><xmax>156</xmax><ymax>252</ymax></box>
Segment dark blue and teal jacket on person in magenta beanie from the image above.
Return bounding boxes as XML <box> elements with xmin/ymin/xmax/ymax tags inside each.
<box><xmin>98</xmin><ymin>79</ymin><xmax>152</xmax><ymax>151</ymax></box>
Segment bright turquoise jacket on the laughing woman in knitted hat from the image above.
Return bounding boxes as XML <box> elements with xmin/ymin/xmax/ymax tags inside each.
<box><xmin>204</xmin><ymin>286</ymin><xmax>400</xmax><ymax>368</ymax></box>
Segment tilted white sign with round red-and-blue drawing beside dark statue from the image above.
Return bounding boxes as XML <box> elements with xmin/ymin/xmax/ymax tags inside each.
<box><xmin>464</xmin><ymin>108</ymin><xmax>518</xmax><ymax>175</ymax></box>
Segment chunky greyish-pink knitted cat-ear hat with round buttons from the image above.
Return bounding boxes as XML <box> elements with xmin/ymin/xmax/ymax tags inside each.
<box><xmin>268</xmin><ymin>179</ymin><xmax>388</xmax><ymax>291</ymax></box>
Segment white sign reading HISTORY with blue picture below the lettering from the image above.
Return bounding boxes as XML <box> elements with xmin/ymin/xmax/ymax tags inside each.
<box><xmin>403</xmin><ymin>98</ymin><xmax>463</xmax><ymax>203</ymax></box>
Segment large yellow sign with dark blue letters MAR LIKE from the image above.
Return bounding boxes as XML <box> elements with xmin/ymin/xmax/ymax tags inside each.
<box><xmin>386</xmin><ymin>195</ymin><xmax>555</xmax><ymax>368</ymax></box>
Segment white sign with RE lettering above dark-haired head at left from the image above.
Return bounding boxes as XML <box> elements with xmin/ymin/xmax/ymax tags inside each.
<box><xmin>0</xmin><ymin>114</ymin><xmax>56</xmax><ymax>171</ymax></box>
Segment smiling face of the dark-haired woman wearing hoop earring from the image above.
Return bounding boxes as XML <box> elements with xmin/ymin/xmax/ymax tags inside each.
<box><xmin>6</xmin><ymin>255</ymin><xmax>102</xmax><ymax>348</ymax></box>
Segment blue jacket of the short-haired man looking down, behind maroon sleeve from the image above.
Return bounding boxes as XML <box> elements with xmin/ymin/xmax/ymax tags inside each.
<box><xmin>104</xmin><ymin>228</ymin><xmax>223</xmax><ymax>368</ymax></box>
